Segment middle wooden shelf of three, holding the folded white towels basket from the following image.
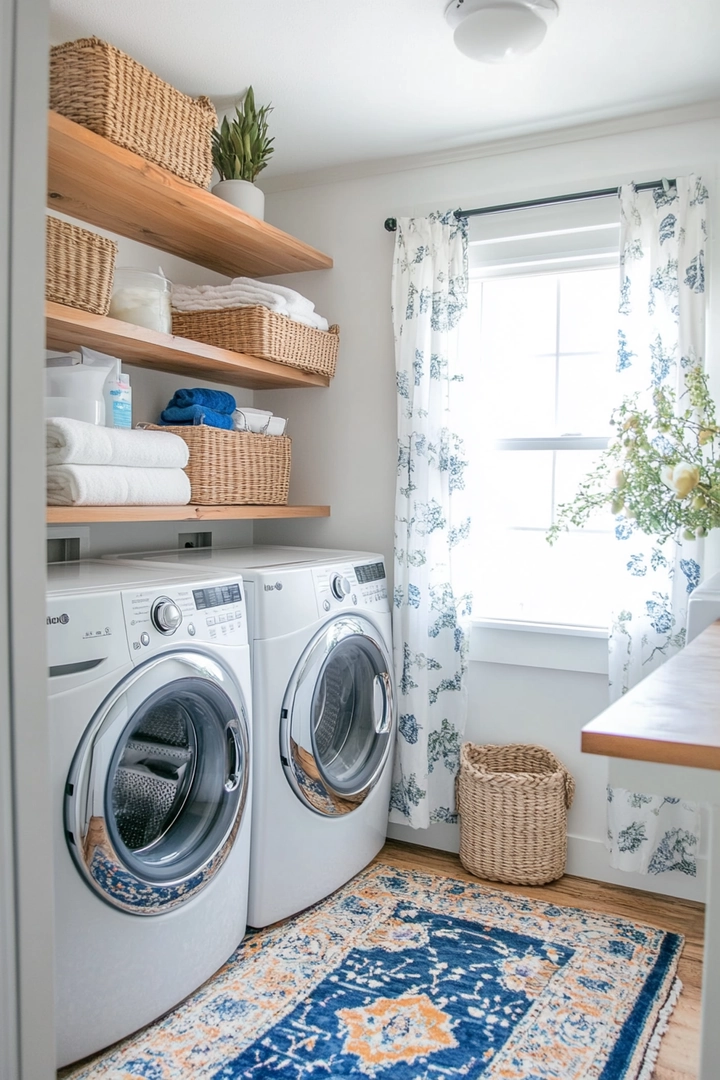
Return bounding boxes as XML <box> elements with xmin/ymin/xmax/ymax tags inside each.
<box><xmin>45</xmin><ymin>301</ymin><xmax>330</xmax><ymax>390</ymax></box>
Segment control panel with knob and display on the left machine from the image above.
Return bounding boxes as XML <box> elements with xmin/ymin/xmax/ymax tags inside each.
<box><xmin>122</xmin><ymin>577</ymin><xmax>247</xmax><ymax>662</ymax></box>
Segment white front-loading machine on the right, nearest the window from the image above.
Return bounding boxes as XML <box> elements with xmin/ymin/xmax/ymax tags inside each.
<box><xmin>108</xmin><ymin>548</ymin><xmax>395</xmax><ymax>927</ymax></box>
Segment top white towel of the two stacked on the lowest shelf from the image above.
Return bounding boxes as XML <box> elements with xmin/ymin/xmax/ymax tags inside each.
<box><xmin>45</xmin><ymin>416</ymin><xmax>189</xmax><ymax>469</ymax></box>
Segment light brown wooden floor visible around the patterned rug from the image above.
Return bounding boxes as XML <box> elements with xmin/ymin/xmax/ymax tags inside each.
<box><xmin>377</xmin><ymin>840</ymin><xmax>705</xmax><ymax>1080</ymax></box>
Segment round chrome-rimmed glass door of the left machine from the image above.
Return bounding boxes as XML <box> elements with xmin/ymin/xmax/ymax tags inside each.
<box><xmin>65</xmin><ymin>651</ymin><xmax>249</xmax><ymax>915</ymax></box>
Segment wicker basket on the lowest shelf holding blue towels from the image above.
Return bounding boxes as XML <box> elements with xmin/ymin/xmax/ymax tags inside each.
<box><xmin>148</xmin><ymin>423</ymin><xmax>291</xmax><ymax>507</ymax></box>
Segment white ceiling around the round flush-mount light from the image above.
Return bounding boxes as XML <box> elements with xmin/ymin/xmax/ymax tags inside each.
<box><xmin>51</xmin><ymin>0</ymin><xmax>720</xmax><ymax>176</ymax></box>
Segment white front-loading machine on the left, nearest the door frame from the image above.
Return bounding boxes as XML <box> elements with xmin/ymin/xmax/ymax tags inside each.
<box><xmin>47</xmin><ymin>561</ymin><xmax>252</xmax><ymax>1066</ymax></box>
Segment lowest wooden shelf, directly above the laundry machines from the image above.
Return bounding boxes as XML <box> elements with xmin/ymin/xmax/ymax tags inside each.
<box><xmin>47</xmin><ymin>505</ymin><xmax>330</xmax><ymax>525</ymax></box>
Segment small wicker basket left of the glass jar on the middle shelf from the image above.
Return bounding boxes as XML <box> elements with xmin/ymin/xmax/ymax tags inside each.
<box><xmin>45</xmin><ymin>216</ymin><xmax>118</xmax><ymax>315</ymax></box>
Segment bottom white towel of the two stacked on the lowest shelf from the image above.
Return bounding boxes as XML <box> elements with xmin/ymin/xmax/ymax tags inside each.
<box><xmin>47</xmin><ymin>464</ymin><xmax>190</xmax><ymax>507</ymax></box>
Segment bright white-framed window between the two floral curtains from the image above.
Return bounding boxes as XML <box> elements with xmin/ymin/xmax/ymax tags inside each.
<box><xmin>465</xmin><ymin>200</ymin><xmax>619</xmax><ymax>626</ymax></box>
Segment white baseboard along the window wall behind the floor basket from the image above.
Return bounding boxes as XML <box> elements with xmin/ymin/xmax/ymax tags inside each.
<box><xmin>388</xmin><ymin>823</ymin><xmax>707</xmax><ymax>903</ymax></box>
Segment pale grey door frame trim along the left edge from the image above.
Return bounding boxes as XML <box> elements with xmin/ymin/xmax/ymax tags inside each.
<box><xmin>0</xmin><ymin>0</ymin><xmax>55</xmax><ymax>1080</ymax></box>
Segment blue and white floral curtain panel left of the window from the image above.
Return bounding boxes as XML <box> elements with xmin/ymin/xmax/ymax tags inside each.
<box><xmin>391</xmin><ymin>212</ymin><xmax>472</xmax><ymax>828</ymax></box>
